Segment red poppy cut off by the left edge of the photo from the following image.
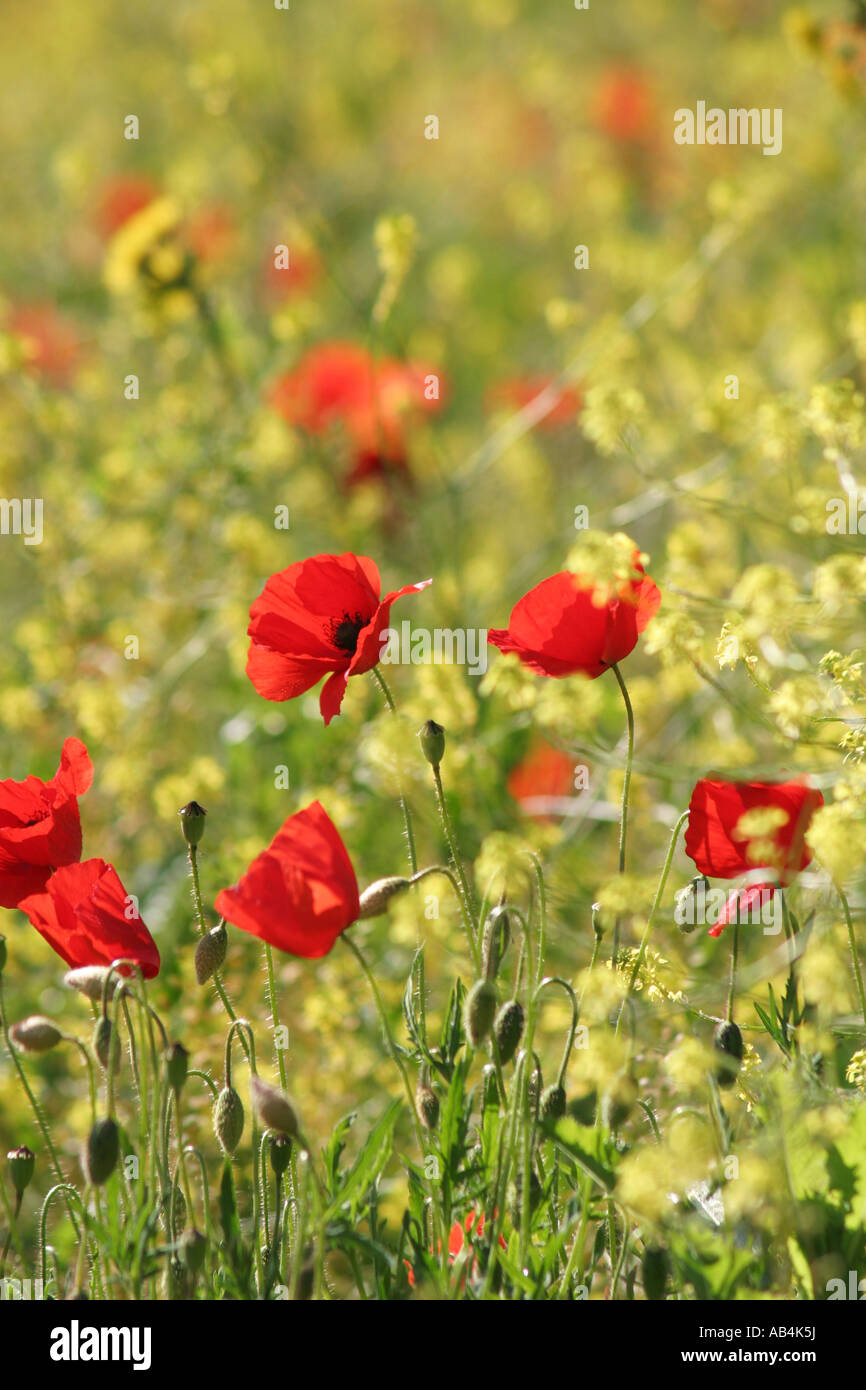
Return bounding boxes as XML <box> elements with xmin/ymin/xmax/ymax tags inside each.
<box><xmin>0</xmin><ymin>738</ymin><xmax>93</xmax><ymax>908</ymax></box>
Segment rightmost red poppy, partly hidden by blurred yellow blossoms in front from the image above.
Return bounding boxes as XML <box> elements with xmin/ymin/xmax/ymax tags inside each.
<box><xmin>685</xmin><ymin>777</ymin><xmax>824</xmax><ymax>937</ymax></box>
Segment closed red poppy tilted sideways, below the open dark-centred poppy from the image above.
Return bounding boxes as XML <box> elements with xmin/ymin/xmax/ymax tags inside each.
<box><xmin>215</xmin><ymin>801</ymin><xmax>360</xmax><ymax>960</ymax></box>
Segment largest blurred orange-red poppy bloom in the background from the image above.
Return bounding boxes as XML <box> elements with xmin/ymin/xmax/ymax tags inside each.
<box><xmin>270</xmin><ymin>342</ymin><xmax>442</xmax><ymax>484</ymax></box>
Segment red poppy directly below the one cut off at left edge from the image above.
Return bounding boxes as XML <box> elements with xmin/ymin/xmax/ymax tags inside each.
<box><xmin>18</xmin><ymin>859</ymin><xmax>160</xmax><ymax>980</ymax></box>
